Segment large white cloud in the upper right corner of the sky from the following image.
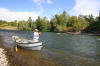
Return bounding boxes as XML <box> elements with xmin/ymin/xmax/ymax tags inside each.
<box><xmin>69</xmin><ymin>0</ymin><xmax>100</xmax><ymax>16</ymax></box>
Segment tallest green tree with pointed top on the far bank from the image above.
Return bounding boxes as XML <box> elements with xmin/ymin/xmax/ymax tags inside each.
<box><xmin>51</xmin><ymin>11</ymin><xmax>69</xmax><ymax>32</ymax></box>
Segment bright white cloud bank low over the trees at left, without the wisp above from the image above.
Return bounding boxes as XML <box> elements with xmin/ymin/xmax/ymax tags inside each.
<box><xmin>0</xmin><ymin>8</ymin><xmax>41</xmax><ymax>21</ymax></box>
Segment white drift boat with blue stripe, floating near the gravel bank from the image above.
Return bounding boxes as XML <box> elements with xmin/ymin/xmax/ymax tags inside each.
<box><xmin>12</xmin><ymin>36</ymin><xmax>42</xmax><ymax>50</ymax></box>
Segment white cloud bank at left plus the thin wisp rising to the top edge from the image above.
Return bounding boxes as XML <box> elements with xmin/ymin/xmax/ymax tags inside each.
<box><xmin>0</xmin><ymin>0</ymin><xmax>53</xmax><ymax>21</ymax></box>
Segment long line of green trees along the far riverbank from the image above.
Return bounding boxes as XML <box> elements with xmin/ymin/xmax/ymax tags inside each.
<box><xmin>0</xmin><ymin>11</ymin><xmax>100</xmax><ymax>32</ymax></box>
